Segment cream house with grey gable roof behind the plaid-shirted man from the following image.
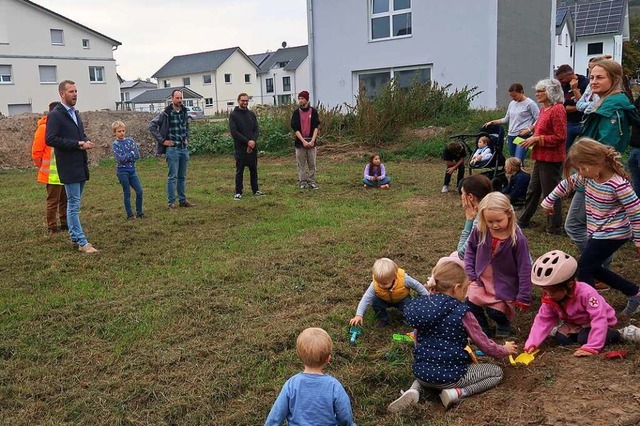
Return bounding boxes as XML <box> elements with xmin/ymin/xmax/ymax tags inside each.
<box><xmin>153</xmin><ymin>47</ymin><xmax>260</xmax><ymax>115</ymax></box>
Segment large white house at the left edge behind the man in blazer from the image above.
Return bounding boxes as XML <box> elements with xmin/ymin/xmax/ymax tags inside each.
<box><xmin>0</xmin><ymin>0</ymin><xmax>121</xmax><ymax>115</ymax></box>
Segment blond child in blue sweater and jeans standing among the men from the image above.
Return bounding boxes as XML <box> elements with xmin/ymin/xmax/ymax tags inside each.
<box><xmin>111</xmin><ymin>121</ymin><xmax>144</xmax><ymax>219</ymax></box>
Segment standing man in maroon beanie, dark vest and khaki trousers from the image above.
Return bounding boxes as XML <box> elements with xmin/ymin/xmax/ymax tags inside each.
<box><xmin>291</xmin><ymin>90</ymin><xmax>320</xmax><ymax>189</ymax></box>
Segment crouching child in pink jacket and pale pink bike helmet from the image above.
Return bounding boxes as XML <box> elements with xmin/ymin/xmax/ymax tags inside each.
<box><xmin>524</xmin><ymin>250</ymin><xmax>620</xmax><ymax>356</ymax></box>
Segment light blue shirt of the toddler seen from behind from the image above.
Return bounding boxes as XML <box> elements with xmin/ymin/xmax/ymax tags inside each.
<box><xmin>264</xmin><ymin>373</ymin><xmax>354</xmax><ymax>426</ymax></box>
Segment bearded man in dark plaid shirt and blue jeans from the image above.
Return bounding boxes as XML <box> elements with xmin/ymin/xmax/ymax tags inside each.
<box><xmin>149</xmin><ymin>89</ymin><xmax>193</xmax><ymax>210</ymax></box>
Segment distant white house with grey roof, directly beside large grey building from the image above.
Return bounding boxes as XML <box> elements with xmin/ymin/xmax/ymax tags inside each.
<box><xmin>250</xmin><ymin>46</ymin><xmax>310</xmax><ymax>105</ymax></box>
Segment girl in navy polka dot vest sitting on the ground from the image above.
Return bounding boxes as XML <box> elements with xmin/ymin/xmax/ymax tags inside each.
<box><xmin>388</xmin><ymin>257</ymin><xmax>518</xmax><ymax>412</ymax></box>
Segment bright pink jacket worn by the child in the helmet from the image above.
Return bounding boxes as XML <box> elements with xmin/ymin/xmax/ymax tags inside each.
<box><xmin>524</xmin><ymin>281</ymin><xmax>618</xmax><ymax>353</ymax></box>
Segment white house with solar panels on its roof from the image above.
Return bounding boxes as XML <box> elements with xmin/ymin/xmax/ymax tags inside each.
<box><xmin>556</xmin><ymin>0</ymin><xmax>629</xmax><ymax>75</ymax></box>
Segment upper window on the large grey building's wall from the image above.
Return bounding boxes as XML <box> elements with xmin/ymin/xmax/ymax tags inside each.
<box><xmin>369</xmin><ymin>0</ymin><xmax>411</xmax><ymax>40</ymax></box>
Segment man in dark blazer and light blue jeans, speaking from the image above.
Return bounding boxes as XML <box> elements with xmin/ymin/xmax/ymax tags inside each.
<box><xmin>46</xmin><ymin>80</ymin><xmax>98</xmax><ymax>254</ymax></box>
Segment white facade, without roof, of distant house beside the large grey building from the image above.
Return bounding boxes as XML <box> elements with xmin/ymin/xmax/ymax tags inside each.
<box><xmin>257</xmin><ymin>57</ymin><xmax>311</xmax><ymax>105</ymax></box>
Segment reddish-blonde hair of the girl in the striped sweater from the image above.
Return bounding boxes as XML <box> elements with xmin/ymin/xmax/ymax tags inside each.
<box><xmin>563</xmin><ymin>138</ymin><xmax>629</xmax><ymax>180</ymax></box>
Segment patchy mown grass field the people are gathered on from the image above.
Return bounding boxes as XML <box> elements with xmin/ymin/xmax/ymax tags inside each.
<box><xmin>0</xmin><ymin>155</ymin><xmax>640</xmax><ymax>425</ymax></box>
